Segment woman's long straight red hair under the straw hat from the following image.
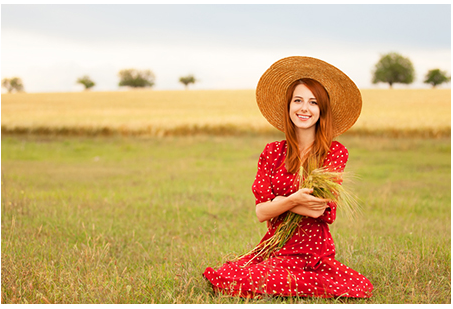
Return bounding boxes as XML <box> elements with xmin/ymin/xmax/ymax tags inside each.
<box><xmin>284</xmin><ymin>78</ymin><xmax>333</xmax><ymax>173</ymax></box>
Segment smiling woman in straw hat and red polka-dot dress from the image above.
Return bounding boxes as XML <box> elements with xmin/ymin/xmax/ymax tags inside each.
<box><xmin>203</xmin><ymin>57</ymin><xmax>373</xmax><ymax>298</ymax></box>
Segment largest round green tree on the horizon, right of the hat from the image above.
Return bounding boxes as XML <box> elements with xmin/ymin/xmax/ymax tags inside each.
<box><xmin>372</xmin><ymin>53</ymin><xmax>415</xmax><ymax>88</ymax></box>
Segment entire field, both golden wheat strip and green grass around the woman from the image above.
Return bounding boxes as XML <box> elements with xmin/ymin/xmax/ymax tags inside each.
<box><xmin>1</xmin><ymin>89</ymin><xmax>451</xmax><ymax>304</ymax></box>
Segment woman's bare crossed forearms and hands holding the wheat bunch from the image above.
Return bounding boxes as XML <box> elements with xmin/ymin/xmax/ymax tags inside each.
<box><xmin>256</xmin><ymin>188</ymin><xmax>328</xmax><ymax>222</ymax></box>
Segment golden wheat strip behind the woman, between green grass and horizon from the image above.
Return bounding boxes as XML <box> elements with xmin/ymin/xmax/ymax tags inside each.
<box><xmin>1</xmin><ymin>89</ymin><xmax>451</xmax><ymax>136</ymax></box>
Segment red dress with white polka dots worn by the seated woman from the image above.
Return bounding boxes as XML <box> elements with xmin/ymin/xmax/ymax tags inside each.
<box><xmin>203</xmin><ymin>141</ymin><xmax>373</xmax><ymax>298</ymax></box>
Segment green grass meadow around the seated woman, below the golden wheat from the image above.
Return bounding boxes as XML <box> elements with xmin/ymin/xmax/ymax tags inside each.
<box><xmin>1</xmin><ymin>135</ymin><xmax>451</xmax><ymax>304</ymax></box>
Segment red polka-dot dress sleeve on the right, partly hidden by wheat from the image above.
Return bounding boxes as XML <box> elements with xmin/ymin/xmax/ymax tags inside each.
<box><xmin>318</xmin><ymin>142</ymin><xmax>349</xmax><ymax>224</ymax></box>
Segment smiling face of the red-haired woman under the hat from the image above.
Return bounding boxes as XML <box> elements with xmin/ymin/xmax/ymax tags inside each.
<box><xmin>289</xmin><ymin>84</ymin><xmax>320</xmax><ymax>133</ymax></box>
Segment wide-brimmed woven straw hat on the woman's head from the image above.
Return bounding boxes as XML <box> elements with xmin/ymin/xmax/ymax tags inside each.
<box><xmin>256</xmin><ymin>56</ymin><xmax>362</xmax><ymax>137</ymax></box>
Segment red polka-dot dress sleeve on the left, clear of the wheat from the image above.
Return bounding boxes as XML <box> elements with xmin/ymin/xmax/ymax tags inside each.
<box><xmin>252</xmin><ymin>144</ymin><xmax>275</xmax><ymax>204</ymax></box>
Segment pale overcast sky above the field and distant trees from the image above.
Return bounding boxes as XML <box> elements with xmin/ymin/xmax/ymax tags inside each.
<box><xmin>1</xmin><ymin>4</ymin><xmax>451</xmax><ymax>92</ymax></box>
